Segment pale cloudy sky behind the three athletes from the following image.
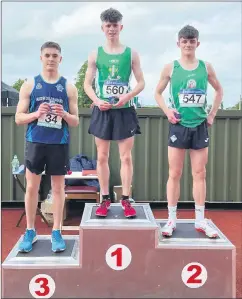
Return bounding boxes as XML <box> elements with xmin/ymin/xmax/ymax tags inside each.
<box><xmin>2</xmin><ymin>2</ymin><xmax>242</xmax><ymax>107</ymax></box>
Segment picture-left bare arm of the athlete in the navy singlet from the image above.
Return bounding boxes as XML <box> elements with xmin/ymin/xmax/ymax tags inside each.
<box><xmin>15</xmin><ymin>80</ymin><xmax>49</xmax><ymax>125</ymax></box>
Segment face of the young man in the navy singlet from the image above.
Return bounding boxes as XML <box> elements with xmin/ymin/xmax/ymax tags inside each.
<box><xmin>40</xmin><ymin>48</ymin><xmax>62</xmax><ymax>72</ymax></box>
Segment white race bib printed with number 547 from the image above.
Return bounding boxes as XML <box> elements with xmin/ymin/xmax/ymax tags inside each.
<box><xmin>179</xmin><ymin>90</ymin><xmax>206</xmax><ymax>107</ymax></box>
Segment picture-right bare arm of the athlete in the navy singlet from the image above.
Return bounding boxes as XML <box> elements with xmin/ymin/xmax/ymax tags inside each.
<box><xmin>63</xmin><ymin>83</ymin><xmax>79</xmax><ymax>127</ymax></box>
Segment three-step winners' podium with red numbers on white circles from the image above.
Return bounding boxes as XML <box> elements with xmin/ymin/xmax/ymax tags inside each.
<box><xmin>2</xmin><ymin>203</ymin><xmax>236</xmax><ymax>298</ymax></box>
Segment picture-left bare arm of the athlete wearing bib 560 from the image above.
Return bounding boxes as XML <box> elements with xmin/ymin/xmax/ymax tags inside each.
<box><xmin>84</xmin><ymin>51</ymin><xmax>112</xmax><ymax>110</ymax></box>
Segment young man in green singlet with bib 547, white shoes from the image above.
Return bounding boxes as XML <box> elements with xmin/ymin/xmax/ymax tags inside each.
<box><xmin>155</xmin><ymin>25</ymin><xmax>223</xmax><ymax>238</ymax></box>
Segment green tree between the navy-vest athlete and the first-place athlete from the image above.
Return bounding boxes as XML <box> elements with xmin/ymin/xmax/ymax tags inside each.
<box><xmin>75</xmin><ymin>61</ymin><xmax>95</xmax><ymax>108</ymax></box>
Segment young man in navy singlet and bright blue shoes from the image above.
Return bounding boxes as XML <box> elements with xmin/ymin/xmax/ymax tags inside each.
<box><xmin>15</xmin><ymin>42</ymin><xmax>79</xmax><ymax>252</ymax></box>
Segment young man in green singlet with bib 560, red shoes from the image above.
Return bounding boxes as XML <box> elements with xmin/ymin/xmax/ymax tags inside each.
<box><xmin>84</xmin><ymin>8</ymin><xmax>145</xmax><ymax>217</ymax></box>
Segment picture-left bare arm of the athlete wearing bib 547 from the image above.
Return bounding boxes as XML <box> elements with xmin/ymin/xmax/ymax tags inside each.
<box><xmin>155</xmin><ymin>63</ymin><xmax>179</xmax><ymax>124</ymax></box>
